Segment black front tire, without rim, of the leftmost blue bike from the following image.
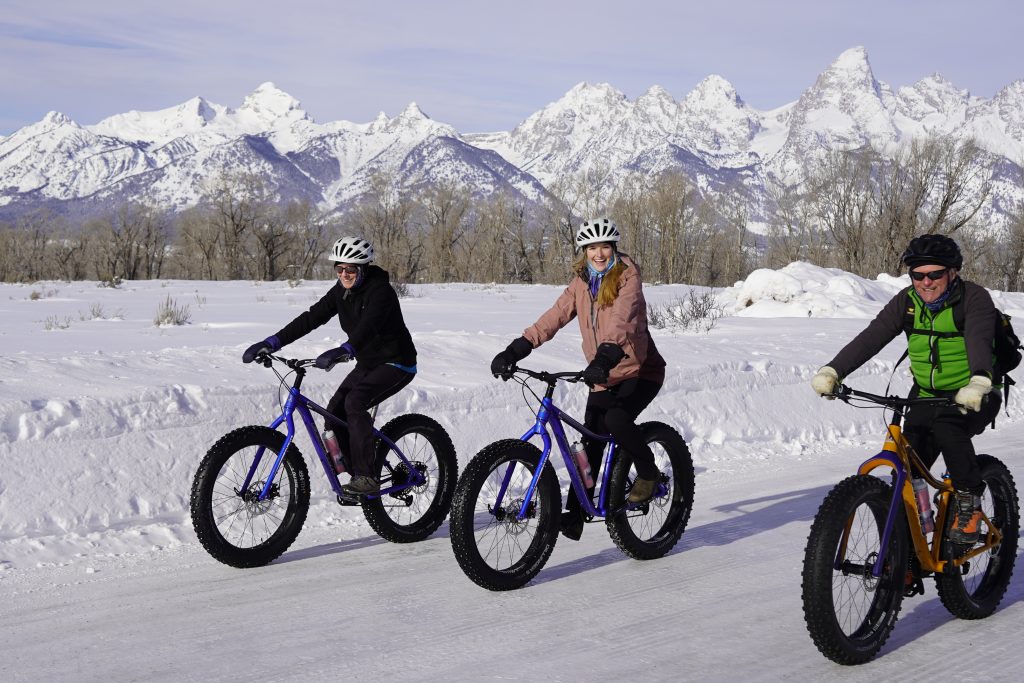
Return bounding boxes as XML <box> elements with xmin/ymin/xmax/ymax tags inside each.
<box><xmin>189</xmin><ymin>426</ymin><xmax>309</xmax><ymax>568</ymax></box>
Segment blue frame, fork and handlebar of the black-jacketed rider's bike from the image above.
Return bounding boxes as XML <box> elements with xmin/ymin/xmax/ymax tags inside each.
<box><xmin>242</xmin><ymin>355</ymin><xmax>425</xmax><ymax>501</ymax></box>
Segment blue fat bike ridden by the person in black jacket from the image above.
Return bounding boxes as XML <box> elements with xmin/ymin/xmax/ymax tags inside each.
<box><xmin>190</xmin><ymin>352</ymin><xmax>458</xmax><ymax>567</ymax></box>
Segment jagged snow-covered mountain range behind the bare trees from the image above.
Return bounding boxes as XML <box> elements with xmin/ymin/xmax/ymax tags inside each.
<box><xmin>0</xmin><ymin>47</ymin><xmax>1024</xmax><ymax>224</ymax></box>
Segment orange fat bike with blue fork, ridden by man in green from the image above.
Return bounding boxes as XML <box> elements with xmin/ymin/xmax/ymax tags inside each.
<box><xmin>802</xmin><ymin>385</ymin><xmax>1020</xmax><ymax>665</ymax></box>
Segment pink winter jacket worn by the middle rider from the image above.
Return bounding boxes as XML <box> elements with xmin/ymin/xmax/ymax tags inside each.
<box><xmin>522</xmin><ymin>254</ymin><xmax>665</xmax><ymax>389</ymax></box>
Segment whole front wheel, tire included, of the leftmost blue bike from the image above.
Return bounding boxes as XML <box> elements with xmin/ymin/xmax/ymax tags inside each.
<box><xmin>190</xmin><ymin>426</ymin><xmax>309</xmax><ymax>568</ymax></box>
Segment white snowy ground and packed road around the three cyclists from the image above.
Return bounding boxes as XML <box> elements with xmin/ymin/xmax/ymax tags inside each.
<box><xmin>0</xmin><ymin>264</ymin><xmax>1024</xmax><ymax>681</ymax></box>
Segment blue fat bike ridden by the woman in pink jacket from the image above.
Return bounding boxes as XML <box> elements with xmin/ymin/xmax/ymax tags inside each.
<box><xmin>450</xmin><ymin>368</ymin><xmax>693</xmax><ymax>591</ymax></box>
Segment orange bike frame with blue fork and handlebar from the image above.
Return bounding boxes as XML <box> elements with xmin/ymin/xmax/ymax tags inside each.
<box><xmin>835</xmin><ymin>387</ymin><xmax>1002</xmax><ymax>579</ymax></box>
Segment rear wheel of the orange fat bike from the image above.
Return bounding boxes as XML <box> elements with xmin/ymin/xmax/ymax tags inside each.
<box><xmin>935</xmin><ymin>455</ymin><xmax>1020</xmax><ymax>618</ymax></box>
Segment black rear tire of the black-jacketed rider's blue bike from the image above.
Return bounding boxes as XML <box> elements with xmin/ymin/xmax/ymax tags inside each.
<box><xmin>362</xmin><ymin>413</ymin><xmax>459</xmax><ymax>543</ymax></box>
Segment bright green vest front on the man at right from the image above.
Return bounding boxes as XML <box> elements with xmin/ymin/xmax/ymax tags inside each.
<box><xmin>904</xmin><ymin>287</ymin><xmax>971</xmax><ymax>396</ymax></box>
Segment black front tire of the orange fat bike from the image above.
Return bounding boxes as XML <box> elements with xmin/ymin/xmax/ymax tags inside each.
<box><xmin>801</xmin><ymin>475</ymin><xmax>909</xmax><ymax>665</ymax></box>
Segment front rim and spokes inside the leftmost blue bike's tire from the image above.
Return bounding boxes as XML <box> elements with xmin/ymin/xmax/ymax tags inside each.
<box><xmin>210</xmin><ymin>445</ymin><xmax>295</xmax><ymax>549</ymax></box>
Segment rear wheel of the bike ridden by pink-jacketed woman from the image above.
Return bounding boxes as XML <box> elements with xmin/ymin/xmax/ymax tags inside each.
<box><xmin>604</xmin><ymin>422</ymin><xmax>693</xmax><ymax>560</ymax></box>
